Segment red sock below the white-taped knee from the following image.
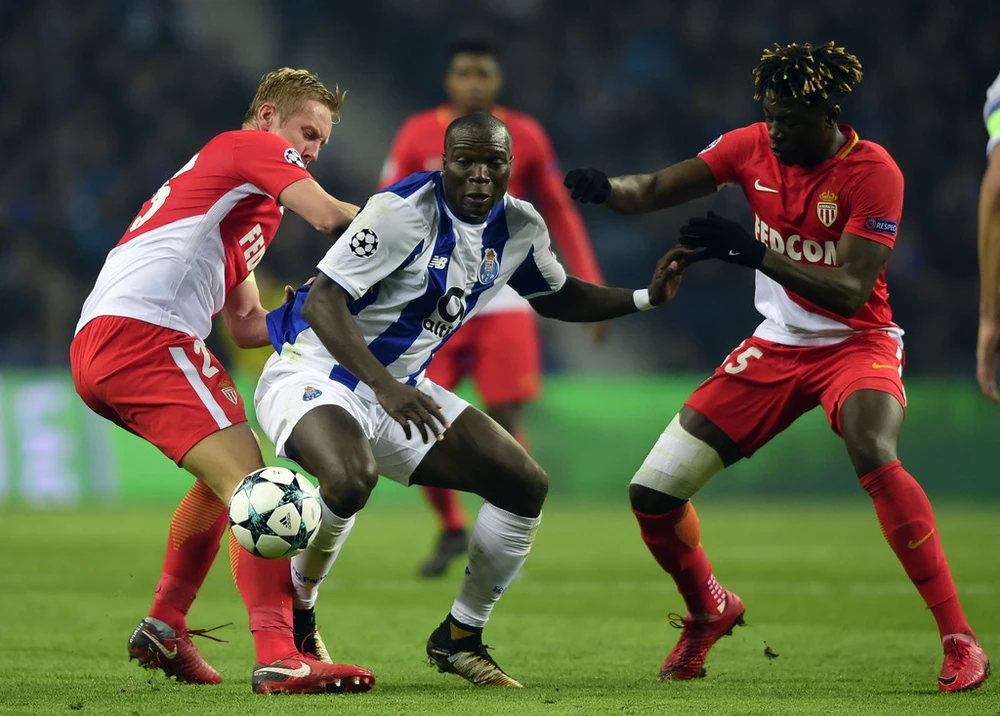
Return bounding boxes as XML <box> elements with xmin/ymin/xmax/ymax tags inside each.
<box><xmin>632</xmin><ymin>502</ymin><xmax>726</xmax><ymax>616</ymax></box>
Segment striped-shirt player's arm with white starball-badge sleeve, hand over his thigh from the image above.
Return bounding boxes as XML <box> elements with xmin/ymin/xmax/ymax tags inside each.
<box><xmin>302</xmin><ymin>194</ymin><xmax>449</xmax><ymax>442</ymax></box>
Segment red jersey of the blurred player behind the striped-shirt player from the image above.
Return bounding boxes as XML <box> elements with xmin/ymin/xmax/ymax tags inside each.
<box><xmin>379</xmin><ymin>105</ymin><xmax>603</xmax><ymax>314</ymax></box>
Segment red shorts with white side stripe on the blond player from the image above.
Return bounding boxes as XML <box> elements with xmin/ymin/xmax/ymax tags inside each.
<box><xmin>69</xmin><ymin>316</ymin><xmax>247</xmax><ymax>464</ymax></box>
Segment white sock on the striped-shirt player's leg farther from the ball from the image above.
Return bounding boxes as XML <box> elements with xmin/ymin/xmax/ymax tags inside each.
<box><xmin>450</xmin><ymin>502</ymin><xmax>542</xmax><ymax>628</ymax></box>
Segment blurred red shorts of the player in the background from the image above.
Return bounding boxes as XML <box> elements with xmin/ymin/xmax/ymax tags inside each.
<box><xmin>427</xmin><ymin>311</ymin><xmax>542</xmax><ymax>407</ymax></box>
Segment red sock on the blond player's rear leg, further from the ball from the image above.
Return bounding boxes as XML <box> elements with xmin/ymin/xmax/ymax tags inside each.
<box><xmin>149</xmin><ymin>480</ymin><xmax>227</xmax><ymax>631</ymax></box>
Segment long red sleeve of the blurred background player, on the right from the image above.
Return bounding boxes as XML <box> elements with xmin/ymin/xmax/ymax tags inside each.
<box><xmin>514</xmin><ymin>114</ymin><xmax>604</xmax><ymax>284</ymax></box>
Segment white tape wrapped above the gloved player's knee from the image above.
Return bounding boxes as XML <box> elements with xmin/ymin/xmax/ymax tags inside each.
<box><xmin>631</xmin><ymin>415</ymin><xmax>723</xmax><ymax>500</ymax></box>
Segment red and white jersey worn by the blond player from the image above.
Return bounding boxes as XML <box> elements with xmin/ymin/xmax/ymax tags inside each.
<box><xmin>76</xmin><ymin>130</ymin><xmax>310</xmax><ymax>339</ymax></box>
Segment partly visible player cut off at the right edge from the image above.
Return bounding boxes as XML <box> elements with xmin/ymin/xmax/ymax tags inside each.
<box><xmin>976</xmin><ymin>75</ymin><xmax>1000</xmax><ymax>403</ymax></box>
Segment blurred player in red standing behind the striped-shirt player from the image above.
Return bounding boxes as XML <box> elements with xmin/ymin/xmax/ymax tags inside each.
<box><xmin>379</xmin><ymin>40</ymin><xmax>607</xmax><ymax>577</ymax></box>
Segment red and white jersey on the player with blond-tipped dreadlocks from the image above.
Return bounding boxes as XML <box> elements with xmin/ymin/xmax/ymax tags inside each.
<box><xmin>699</xmin><ymin>122</ymin><xmax>903</xmax><ymax>345</ymax></box>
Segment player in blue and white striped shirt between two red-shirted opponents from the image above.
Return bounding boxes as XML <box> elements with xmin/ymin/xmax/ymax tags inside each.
<box><xmin>254</xmin><ymin>113</ymin><xmax>685</xmax><ymax>687</ymax></box>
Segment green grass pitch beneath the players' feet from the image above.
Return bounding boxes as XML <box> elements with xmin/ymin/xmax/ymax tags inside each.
<box><xmin>0</xmin><ymin>495</ymin><xmax>1000</xmax><ymax>716</ymax></box>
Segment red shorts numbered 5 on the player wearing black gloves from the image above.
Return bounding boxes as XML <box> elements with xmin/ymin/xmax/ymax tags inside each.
<box><xmin>684</xmin><ymin>331</ymin><xmax>906</xmax><ymax>457</ymax></box>
